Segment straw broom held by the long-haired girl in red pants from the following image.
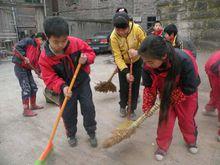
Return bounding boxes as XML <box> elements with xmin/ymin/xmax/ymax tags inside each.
<box><xmin>102</xmin><ymin>103</ymin><xmax>159</xmax><ymax>148</ymax></box>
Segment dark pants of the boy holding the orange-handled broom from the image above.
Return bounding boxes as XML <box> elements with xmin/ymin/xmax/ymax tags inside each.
<box><xmin>60</xmin><ymin>78</ymin><xmax>96</xmax><ymax>137</ymax></box>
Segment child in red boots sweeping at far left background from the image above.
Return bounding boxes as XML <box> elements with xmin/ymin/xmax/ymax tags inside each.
<box><xmin>12</xmin><ymin>33</ymin><xmax>46</xmax><ymax>117</ymax></box>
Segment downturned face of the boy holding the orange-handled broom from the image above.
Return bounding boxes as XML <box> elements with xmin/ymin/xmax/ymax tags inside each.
<box><xmin>48</xmin><ymin>36</ymin><xmax>68</xmax><ymax>53</ymax></box>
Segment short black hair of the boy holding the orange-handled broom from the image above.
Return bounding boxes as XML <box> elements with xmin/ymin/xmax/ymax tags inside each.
<box><xmin>43</xmin><ymin>17</ymin><xmax>69</xmax><ymax>38</ymax></box>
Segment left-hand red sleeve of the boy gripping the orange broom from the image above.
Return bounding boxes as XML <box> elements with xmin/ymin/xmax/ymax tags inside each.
<box><xmin>39</xmin><ymin>56</ymin><xmax>67</xmax><ymax>94</ymax></box>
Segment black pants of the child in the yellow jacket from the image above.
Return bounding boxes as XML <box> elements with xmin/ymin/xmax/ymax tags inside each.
<box><xmin>118</xmin><ymin>59</ymin><xmax>143</xmax><ymax>112</ymax></box>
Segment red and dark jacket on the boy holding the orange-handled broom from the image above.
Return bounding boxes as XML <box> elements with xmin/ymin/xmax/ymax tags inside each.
<box><xmin>39</xmin><ymin>36</ymin><xmax>95</xmax><ymax>93</ymax></box>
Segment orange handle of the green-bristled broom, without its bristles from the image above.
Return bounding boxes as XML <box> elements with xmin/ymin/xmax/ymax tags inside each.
<box><xmin>39</xmin><ymin>63</ymin><xmax>81</xmax><ymax>160</ymax></box>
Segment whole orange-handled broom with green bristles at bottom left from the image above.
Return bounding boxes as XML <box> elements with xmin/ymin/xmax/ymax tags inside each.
<box><xmin>35</xmin><ymin>63</ymin><xmax>81</xmax><ymax>165</ymax></box>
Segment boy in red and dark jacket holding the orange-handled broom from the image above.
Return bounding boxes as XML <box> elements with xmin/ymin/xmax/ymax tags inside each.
<box><xmin>39</xmin><ymin>17</ymin><xmax>97</xmax><ymax>147</ymax></box>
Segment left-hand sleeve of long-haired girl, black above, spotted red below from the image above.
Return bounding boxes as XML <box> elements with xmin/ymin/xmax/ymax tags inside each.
<box><xmin>142</xmin><ymin>69</ymin><xmax>157</xmax><ymax>112</ymax></box>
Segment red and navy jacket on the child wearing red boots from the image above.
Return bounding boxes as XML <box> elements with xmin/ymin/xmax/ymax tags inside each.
<box><xmin>12</xmin><ymin>38</ymin><xmax>40</xmax><ymax>71</ymax></box>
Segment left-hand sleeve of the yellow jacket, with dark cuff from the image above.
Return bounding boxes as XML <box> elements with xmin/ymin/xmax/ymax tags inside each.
<box><xmin>110</xmin><ymin>36</ymin><xmax>129</xmax><ymax>73</ymax></box>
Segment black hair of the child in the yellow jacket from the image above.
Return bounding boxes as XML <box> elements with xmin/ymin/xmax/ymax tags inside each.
<box><xmin>113</xmin><ymin>11</ymin><xmax>130</xmax><ymax>29</ymax></box>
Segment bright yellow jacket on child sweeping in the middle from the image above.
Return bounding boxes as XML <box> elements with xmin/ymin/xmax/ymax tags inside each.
<box><xmin>110</xmin><ymin>22</ymin><xmax>146</xmax><ymax>71</ymax></box>
